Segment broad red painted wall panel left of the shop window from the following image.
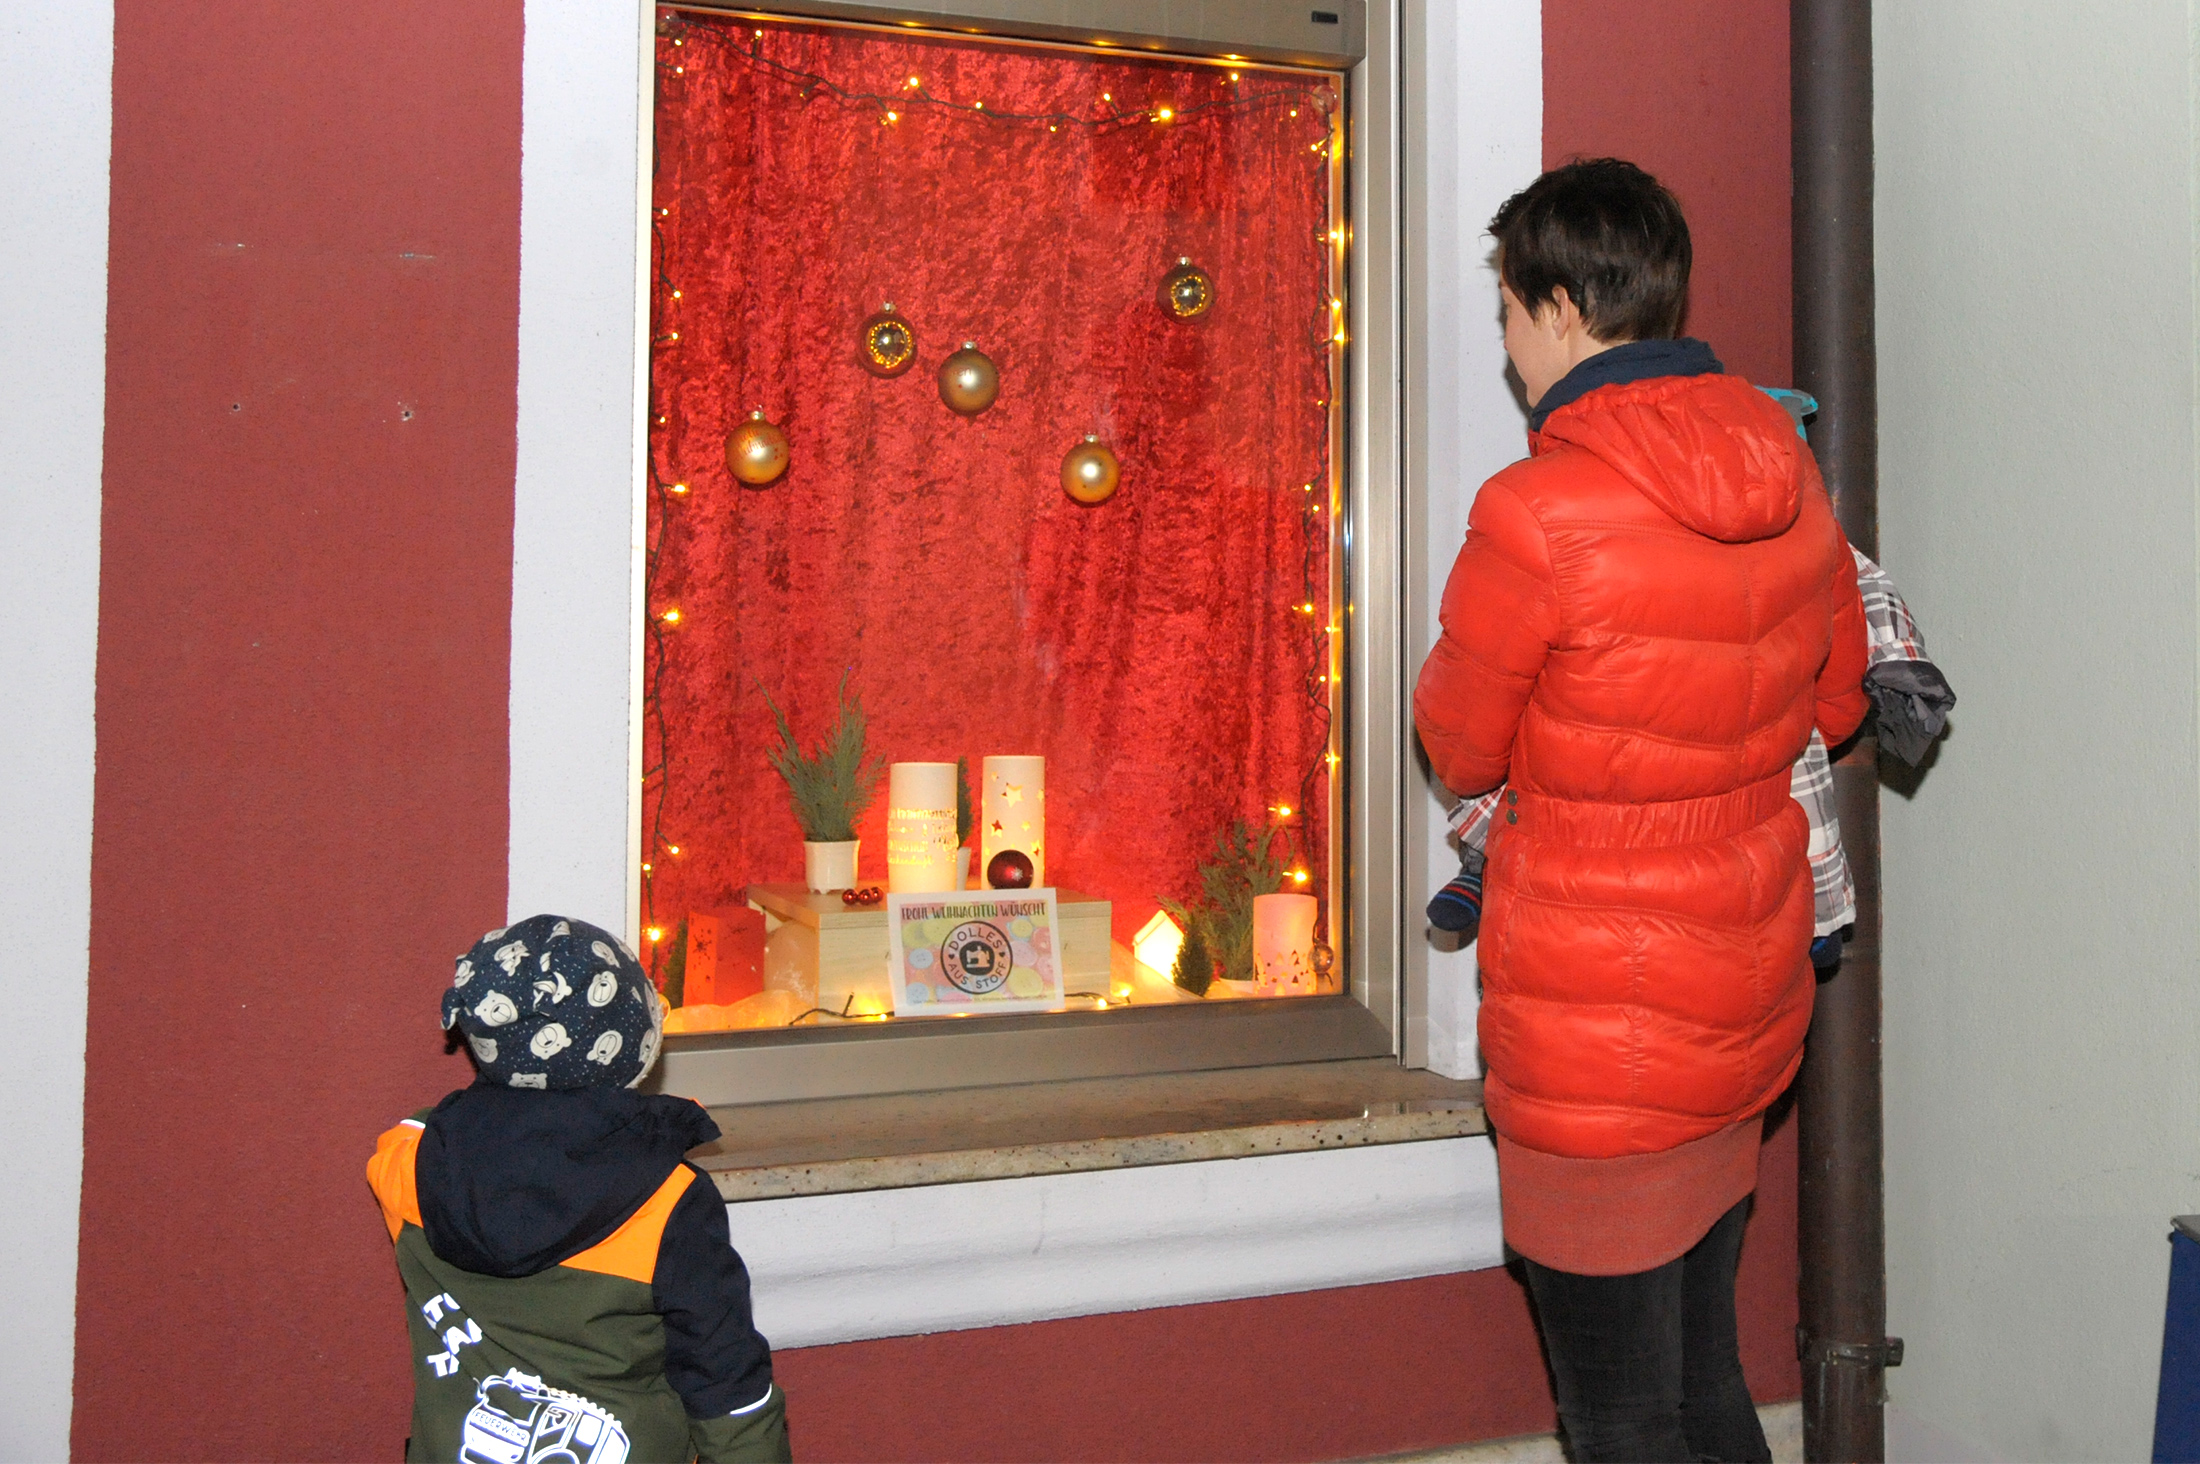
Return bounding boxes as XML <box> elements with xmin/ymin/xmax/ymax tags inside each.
<box><xmin>75</xmin><ymin>0</ymin><xmax>519</xmax><ymax>1460</ymax></box>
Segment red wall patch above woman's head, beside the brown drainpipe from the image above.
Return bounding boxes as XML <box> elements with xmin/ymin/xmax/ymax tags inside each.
<box><xmin>1542</xmin><ymin>0</ymin><xmax>1793</xmax><ymax>385</ymax></box>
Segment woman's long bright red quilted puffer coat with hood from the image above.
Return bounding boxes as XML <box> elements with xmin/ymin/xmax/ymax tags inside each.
<box><xmin>1412</xmin><ymin>374</ymin><xmax>1866</xmax><ymax>1158</ymax></box>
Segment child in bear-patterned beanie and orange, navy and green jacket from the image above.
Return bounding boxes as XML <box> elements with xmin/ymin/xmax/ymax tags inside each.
<box><xmin>367</xmin><ymin>916</ymin><xmax>790</xmax><ymax>1464</ymax></box>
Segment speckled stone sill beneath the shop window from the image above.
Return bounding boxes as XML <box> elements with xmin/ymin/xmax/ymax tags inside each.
<box><xmin>689</xmin><ymin>1057</ymin><xmax>1487</xmax><ymax>1202</ymax></box>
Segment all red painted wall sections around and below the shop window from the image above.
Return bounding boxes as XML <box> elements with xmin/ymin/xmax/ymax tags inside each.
<box><xmin>75</xmin><ymin>0</ymin><xmax>1800</xmax><ymax>1460</ymax></box>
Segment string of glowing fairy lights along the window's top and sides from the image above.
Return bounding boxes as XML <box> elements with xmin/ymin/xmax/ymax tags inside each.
<box><xmin>640</xmin><ymin>11</ymin><xmax>1346</xmax><ymax>977</ymax></box>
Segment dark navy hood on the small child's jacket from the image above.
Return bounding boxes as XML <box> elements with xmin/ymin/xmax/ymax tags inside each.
<box><xmin>414</xmin><ymin>1083</ymin><xmax>719</xmax><ymax>1277</ymax></box>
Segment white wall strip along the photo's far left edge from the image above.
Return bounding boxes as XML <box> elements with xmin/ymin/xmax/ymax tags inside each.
<box><xmin>0</xmin><ymin>0</ymin><xmax>114</xmax><ymax>1460</ymax></box>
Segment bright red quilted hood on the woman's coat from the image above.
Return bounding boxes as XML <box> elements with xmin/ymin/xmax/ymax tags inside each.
<box><xmin>1533</xmin><ymin>367</ymin><xmax>1804</xmax><ymax>544</ymax></box>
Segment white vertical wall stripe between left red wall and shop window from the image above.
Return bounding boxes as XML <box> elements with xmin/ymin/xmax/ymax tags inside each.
<box><xmin>506</xmin><ymin>0</ymin><xmax>653</xmax><ymax>940</ymax></box>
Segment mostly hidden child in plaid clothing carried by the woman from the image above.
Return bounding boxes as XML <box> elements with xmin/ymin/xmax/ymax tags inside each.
<box><xmin>1428</xmin><ymin>541</ymin><xmax>1956</xmax><ymax>955</ymax></box>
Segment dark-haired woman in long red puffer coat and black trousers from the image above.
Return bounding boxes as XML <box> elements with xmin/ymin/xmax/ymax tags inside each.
<box><xmin>1415</xmin><ymin>161</ymin><xmax>1868</xmax><ymax>1460</ymax></box>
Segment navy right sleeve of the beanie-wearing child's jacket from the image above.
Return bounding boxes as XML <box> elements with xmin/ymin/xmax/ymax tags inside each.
<box><xmin>653</xmin><ymin>1169</ymin><xmax>788</xmax><ymax>1464</ymax></box>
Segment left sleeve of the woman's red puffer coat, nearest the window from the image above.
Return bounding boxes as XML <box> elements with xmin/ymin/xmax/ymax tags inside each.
<box><xmin>1412</xmin><ymin>480</ymin><xmax>1560</xmax><ymax>795</ymax></box>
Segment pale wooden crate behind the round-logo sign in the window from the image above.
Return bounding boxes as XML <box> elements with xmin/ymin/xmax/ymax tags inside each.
<box><xmin>748</xmin><ymin>885</ymin><xmax>1115</xmax><ymax>1015</ymax></box>
